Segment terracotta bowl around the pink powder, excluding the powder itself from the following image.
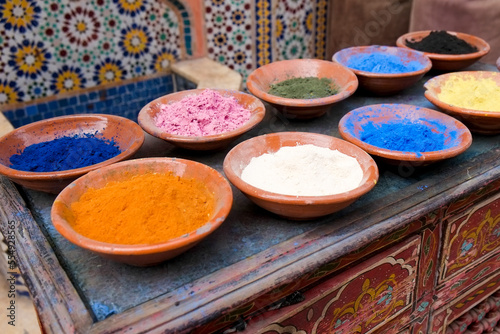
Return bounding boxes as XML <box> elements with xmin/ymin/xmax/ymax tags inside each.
<box><xmin>138</xmin><ymin>89</ymin><xmax>266</xmax><ymax>151</ymax></box>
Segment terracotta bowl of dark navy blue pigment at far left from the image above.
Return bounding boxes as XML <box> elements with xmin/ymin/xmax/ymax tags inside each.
<box><xmin>0</xmin><ymin>114</ymin><xmax>144</xmax><ymax>194</ymax></box>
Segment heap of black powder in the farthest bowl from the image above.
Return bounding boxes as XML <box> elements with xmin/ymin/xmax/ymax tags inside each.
<box><xmin>406</xmin><ymin>30</ymin><xmax>477</xmax><ymax>55</ymax></box>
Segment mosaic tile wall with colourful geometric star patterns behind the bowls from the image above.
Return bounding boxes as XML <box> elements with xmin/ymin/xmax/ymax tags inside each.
<box><xmin>0</xmin><ymin>0</ymin><xmax>327</xmax><ymax>127</ymax></box>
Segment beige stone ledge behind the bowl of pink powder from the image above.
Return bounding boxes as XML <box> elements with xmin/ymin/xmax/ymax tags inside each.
<box><xmin>171</xmin><ymin>57</ymin><xmax>243</xmax><ymax>90</ymax></box>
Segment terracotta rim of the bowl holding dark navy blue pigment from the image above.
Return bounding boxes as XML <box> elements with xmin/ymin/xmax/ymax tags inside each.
<box><xmin>0</xmin><ymin>114</ymin><xmax>145</xmax><ymax>181</ymax></box>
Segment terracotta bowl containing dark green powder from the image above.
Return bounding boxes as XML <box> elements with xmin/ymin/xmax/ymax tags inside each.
<box><xmin>247</xmin><ymin>59</ymin><xmax>358</xmax><ymax>119</ymax></box>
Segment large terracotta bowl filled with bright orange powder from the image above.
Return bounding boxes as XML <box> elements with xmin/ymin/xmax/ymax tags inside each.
<box><xmin>51</xmin><ymin>158</ymin><xmax>233</xmax><ymax>266</ymax></box>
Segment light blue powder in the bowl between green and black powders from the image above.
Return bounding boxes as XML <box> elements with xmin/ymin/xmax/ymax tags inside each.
<box><xmin>347</xmin><ymin>52</ymin><xmax>424</xmax><ymax>74</ymax></box>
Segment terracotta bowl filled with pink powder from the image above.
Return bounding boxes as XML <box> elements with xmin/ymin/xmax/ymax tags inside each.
<box><xmin>138</xmin><ymin>88</ymin><xmax>266</xmax><ymax>151</ymax></box>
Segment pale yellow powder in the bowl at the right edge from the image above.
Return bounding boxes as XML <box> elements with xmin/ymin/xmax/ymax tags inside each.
<box><xmin>438</xmin><ymin>76</ymin><xmax>500</xmax><ymax>111</ymax></box>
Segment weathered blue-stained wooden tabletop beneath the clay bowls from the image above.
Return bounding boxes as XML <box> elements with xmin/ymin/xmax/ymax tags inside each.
<box><xmin>0</xmin><ymin>65</ymin><xmax>500</xmax><ymax>333</ymax></box>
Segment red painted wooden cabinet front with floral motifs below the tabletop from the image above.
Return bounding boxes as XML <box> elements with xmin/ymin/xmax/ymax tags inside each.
<box><xmin>195</xmin><ymin>181</ymin><xmax>500</xmax><ymax>334</ymax></box>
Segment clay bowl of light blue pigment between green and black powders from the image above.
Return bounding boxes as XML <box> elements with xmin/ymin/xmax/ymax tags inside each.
<box><xmin>332</xmin><ymin>45</ymin><xmax>432</xmax><ymax>95</ymax></box>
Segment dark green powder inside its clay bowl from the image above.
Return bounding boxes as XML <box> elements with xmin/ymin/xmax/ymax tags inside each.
<box><xmin>268</xmin><ymin>77</ymin><xmax>338</xmax><ymax>99</ymax></box>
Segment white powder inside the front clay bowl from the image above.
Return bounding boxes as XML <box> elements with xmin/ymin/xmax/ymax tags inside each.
<box><xmin>241</xmin><ymin>145</ymin><xmax>363</xmax><ymax>196</ymax></box>
